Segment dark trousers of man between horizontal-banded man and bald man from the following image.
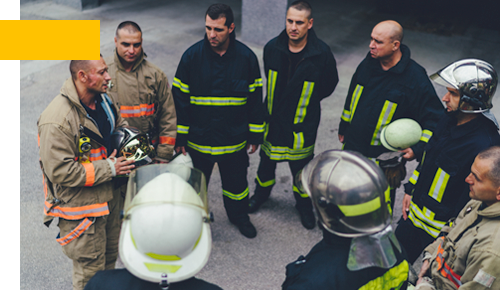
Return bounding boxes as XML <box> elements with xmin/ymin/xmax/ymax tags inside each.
<box><xmin>255</xmin><ymin>150</ymin><xmax>314</xmax><ymax>210</ymax></box>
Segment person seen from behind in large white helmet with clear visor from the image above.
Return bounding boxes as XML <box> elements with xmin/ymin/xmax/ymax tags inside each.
<box><xmin>85</xmin><ymin>164</ymin><xmax>221</xmax><ymax>290</ymax></box>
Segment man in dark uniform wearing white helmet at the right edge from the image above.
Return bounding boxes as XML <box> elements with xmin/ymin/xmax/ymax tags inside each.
<box><xmin>396</xmin><ymin>59</ymin><xmax>500</xmax><ymax>263</ymax></box>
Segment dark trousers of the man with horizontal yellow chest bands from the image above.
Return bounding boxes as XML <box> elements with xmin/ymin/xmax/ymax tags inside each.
<box><xmin>188</xmin><ymin>147</ymin><xmax>250</xmax><ymax>224</ymax></box>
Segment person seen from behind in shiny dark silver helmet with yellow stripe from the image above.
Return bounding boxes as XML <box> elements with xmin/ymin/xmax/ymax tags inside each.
<box><xmin>283</xmin><ymin>150</ymin><xmax>409</xmax><ymax>290</ymax></box>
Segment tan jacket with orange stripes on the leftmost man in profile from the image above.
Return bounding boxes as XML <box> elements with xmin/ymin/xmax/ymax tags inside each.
<box><xmin>38</xmin><ymin>78</ymin><xmax>128</xmax><ymax>226</ymax></box>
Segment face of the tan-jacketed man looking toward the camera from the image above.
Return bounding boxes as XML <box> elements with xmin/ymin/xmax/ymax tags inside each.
<box><xmin>115</xmin><ymin>29</ymin><xmax>142</xmax><ymax>64</ymax></box>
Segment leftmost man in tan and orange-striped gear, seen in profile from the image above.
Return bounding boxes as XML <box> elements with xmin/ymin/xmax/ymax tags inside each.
<box><xmin>38</xmin><ymin>56</ymin><xmax>134</xmax><ymax>290</ymax></box>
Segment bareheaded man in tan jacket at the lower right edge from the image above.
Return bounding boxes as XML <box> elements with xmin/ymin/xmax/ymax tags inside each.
<box><xmin>415</xmin><ymin>146</ymin><xmax>500</xmax><ymax>290</ymax></box>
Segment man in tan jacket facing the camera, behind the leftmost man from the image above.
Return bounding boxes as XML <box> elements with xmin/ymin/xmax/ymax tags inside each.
<box><xmin>107</xmin><ymin>21</ymin><xmax>177</xmax><ymax>162</ymax></box>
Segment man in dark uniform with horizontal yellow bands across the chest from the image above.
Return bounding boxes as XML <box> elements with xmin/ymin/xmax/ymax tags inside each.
<box><xmin>172</xmin><ymin>4</ymin><xmax>264</xmax><ymax>238</ymax></box>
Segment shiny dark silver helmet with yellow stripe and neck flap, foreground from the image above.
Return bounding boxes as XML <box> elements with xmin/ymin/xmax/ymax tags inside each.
<box><xmin>297</xmin><ymin>150</ymin><xmax>401</xmax><ymax>271</ymax></box>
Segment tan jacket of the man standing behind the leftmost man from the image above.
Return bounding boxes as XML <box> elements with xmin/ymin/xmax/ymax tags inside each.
<box><xmin>106</xmin><ymin>50</ymin><xmax>177</xmax><ymax>160</ymax></box>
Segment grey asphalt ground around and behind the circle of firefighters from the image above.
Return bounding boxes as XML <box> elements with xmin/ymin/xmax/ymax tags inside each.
<box><xmin>20</xmin><ymin>0</ymin><xmax>500</xmax><ymax>290</ymax></box>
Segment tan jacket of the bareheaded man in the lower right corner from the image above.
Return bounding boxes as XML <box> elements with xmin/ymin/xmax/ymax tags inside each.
<box><xmin>422</xmin><ymin>200</ymin><xmax>500</xmax><ymax>290</ymax></box>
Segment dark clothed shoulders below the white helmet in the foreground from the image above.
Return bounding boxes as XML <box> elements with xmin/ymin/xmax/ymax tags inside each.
<box><xmin>84</xmin><ymin>269</ymin><xmax>222</xmax><ymax>290</ymax></box>
